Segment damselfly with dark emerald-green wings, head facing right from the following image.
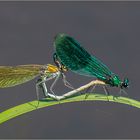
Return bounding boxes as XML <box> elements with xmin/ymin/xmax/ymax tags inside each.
<box><xmin>54</xmin><ymin>33</ymin><xmax>129</xmax><ymax>93</ymax></box>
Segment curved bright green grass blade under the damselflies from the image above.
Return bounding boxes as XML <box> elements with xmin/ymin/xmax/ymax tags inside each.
<box><xmin>0</xmin><ymin>94</ymin><xmax>140</xmax><ymax>124</ymax></box>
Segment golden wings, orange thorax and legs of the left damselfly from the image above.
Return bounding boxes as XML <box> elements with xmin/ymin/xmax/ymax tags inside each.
<box><xmin>0</xmin><ymin>64</ymin><xmax>68</xmax><ymax>100</ymax></box>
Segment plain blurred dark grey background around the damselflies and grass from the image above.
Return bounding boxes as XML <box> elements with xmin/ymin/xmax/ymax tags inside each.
<box><xmin>0</xmin><ymin>1</ymin><xmax>140</xmax><ymax>138</ymax></box>
